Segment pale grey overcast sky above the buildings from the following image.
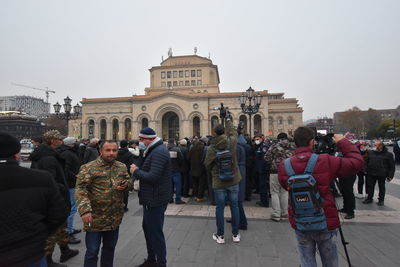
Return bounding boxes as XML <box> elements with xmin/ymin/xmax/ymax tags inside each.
<box><xmin>0</xmin><ymin>0</ymin><xmax>400</xmax><ymax>120</ymax></box>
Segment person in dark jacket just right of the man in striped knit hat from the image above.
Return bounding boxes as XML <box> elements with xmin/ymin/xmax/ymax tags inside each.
<box><xmin>167</xmin><ymin>138</ymin><xmax>186</xmax><ymax>205</ymax></box>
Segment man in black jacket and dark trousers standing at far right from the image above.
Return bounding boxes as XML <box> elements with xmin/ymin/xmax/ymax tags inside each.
<box><xmin>363</xmin><ymin>141</ymin><xmax>395</xmax><ymax>206</ymax></box>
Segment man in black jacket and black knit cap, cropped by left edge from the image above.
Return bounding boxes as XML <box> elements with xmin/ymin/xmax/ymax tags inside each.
<box><xmin>0</xmin><ymin>133</ymin><xmax>68</xmax><ymax>266</ymax></box>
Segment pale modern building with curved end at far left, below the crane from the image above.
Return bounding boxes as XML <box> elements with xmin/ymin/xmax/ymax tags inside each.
<box><xmin>0</xmin><ymin>95</ymin><xmax>50</xmax><ymax>118</ymax></box>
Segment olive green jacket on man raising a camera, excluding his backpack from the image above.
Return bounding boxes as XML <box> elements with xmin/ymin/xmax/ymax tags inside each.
<box><xmin>204</xmin><ymin>120</ymin><xmax>242</xmax><ymax>189</ymax></box>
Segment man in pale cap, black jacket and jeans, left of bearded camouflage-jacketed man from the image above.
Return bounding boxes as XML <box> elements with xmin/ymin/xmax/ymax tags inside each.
<box><xmin>57</xmin><ymin>137</ymin><xmax>81</xmax><ymax>244</ymax></box>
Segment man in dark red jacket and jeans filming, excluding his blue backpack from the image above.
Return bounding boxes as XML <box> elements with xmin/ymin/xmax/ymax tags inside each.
<box><xmin>278</xmin><ymin>127</ymin><xmax>363</xmax><ymax>267</ymax></box>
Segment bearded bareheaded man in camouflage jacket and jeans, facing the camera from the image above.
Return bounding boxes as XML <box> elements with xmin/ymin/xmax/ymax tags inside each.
<box><xmin>75</xmin><ymin>141</ymin><xmax>132</xmax><ymax>267</ymax></box>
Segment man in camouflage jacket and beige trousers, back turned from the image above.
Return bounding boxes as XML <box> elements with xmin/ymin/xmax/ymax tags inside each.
<box><xmin>265</xmin><ymin>133</ymin><xmax>296</xmax><ymax>221</ymax></box>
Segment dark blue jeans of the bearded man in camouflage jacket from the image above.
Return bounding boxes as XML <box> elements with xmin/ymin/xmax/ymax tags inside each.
<box><xmin>84</xmin><ymin>228</ymin><xmax>119</xmax><ymax>267</ymax></box>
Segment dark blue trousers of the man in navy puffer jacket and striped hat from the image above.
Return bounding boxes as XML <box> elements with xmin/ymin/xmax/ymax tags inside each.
<box><xmin>142</xmin><ymin>205</ymin><xmax>167</xmax><ymax>265</ymax></box>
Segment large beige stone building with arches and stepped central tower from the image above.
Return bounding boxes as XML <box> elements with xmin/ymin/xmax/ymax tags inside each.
<box><xmin>75</xmin><ymin>55</ymin><xmax>303</xmax><ymax>140</ymax></box>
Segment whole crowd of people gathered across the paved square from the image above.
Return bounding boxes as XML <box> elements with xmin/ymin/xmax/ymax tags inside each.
<box><xmin>0</xmin><ymin>120</ymin><xmax>397</xmax><ymax>267</ymax></box>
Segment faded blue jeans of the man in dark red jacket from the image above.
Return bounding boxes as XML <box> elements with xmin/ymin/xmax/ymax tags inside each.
<box><xmin>296</xmin><ymin>229</ymin><xmax>339</xmax><ymax>267</ymax></box>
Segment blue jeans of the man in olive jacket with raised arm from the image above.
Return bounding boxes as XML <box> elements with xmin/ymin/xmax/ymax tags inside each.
<box><xmin>214</xmin><ymin>184</ymin><xmax>239</xmax><ymax>236</ymax></box>
